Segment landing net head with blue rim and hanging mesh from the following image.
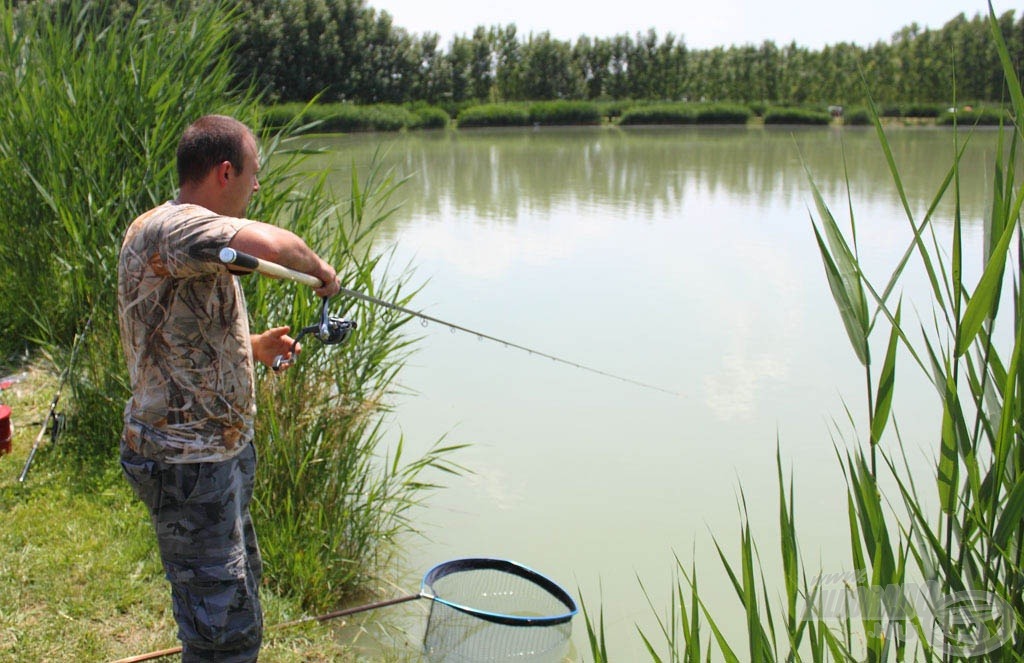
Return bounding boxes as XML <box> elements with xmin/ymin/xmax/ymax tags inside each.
<box><xmin>423</xmin><ymin>560</ymin><xmax>575</xmax><ymax>663</ymax></box>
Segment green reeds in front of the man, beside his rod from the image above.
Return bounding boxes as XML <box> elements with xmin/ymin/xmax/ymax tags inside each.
<box><xmin>241</xmin><ymin>142</ymin><xmax>460</xmax><ymax>610</ymax></box>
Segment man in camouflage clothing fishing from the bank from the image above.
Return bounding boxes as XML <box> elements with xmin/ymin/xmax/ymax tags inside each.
<box><xmin>118</xmin><ymin>116</ymin><xmax>339</xmax><ymax>662</ymax></box>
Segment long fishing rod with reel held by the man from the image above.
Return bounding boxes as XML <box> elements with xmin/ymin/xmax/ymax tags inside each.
<box><xmin>218</xmin><ymin>248</ymin><xmax>682</xmax><ymax>397</ymax></box>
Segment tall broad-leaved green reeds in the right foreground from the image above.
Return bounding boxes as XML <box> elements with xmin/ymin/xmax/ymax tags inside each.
<box><xmin>587</xmin><ymin>6</ymin><xmax>1024</xmax><ymax>662</ymax></box>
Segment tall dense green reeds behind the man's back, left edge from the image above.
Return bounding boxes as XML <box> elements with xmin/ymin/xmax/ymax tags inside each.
<box><xmin>0</xmin><ymin>0</ymin><xmax>248</xmax><ymax>473</ymax></box>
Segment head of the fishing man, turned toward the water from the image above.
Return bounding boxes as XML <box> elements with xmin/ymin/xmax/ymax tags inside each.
<box><xmin>177</xmin><ymin>115</ymin><xmax>259</xmax><ymax>216</ymax></box>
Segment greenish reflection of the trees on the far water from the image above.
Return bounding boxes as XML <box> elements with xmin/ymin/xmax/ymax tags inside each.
<box><xmin>309</xmin><ymin>127</ymin><xmax>1007</xmax><ymax>230</ymax></box>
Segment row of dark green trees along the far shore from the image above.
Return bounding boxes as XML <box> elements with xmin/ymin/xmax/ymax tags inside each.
<box><xmin>15</xmin><ymin>0</ymin><xmax>1024</xmax><ymax>110</ymax></box>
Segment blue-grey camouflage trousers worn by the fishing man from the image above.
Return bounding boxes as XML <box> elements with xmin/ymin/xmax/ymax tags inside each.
<box><xmin>121</xmin><ymin>442</ymin><xmax>263</xmax><ymax>663</ymax></box>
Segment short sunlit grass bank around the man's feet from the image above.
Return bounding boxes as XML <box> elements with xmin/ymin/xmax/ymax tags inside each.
<box><xmin>0</xmin><ymin>363</ymin><xmax>355</xmax><ymax>663</ymax></box>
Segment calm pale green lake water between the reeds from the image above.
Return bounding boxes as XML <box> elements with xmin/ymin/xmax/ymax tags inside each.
<box><xmin>303</xmin><ymin>127</ymin><xmax>996</xmax><ymax>661</ymax></box>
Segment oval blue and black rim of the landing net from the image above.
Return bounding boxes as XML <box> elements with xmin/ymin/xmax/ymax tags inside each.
<box><xmin>420</xmin><ymin>557</ymin><xmax>579</xmax><ymax>626</ymax></box>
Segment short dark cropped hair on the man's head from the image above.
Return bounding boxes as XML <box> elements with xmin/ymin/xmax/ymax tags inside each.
<box><xmin>177</xmin><ymin>115</ymin><xmax>252</xmax><ymax>187</ymax></box>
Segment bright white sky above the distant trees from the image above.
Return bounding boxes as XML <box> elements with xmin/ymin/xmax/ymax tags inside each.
<box><xmin>366</xmin><ymin>0</ymin><xmax>999</xmax><ymax>49</ymax></box>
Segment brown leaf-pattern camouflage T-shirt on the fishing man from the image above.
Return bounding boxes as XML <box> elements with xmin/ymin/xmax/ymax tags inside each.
<box><xmin>118</xmin><ymin>202</ymin><xmax>256</xmax><ymax>463</ymax></box>
